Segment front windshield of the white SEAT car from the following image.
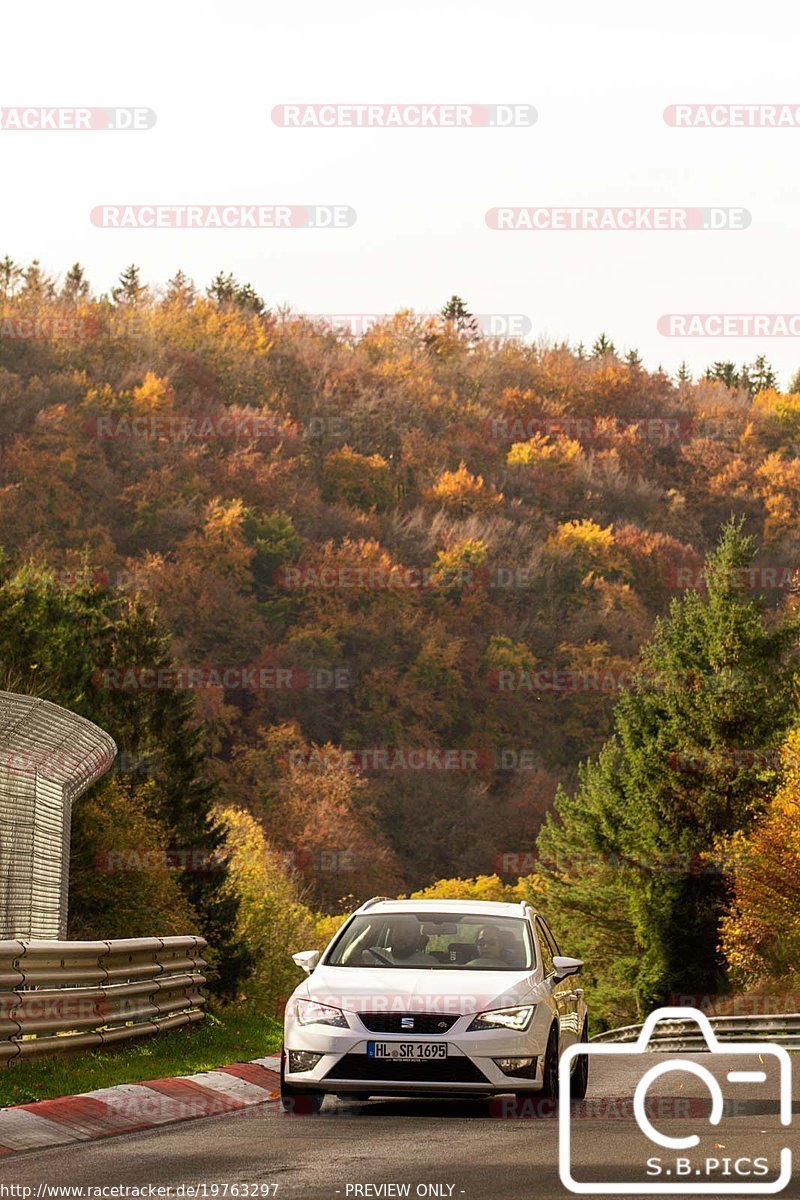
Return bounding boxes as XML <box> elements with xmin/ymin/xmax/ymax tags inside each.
<box><xmin>325</xmin><ymin>912</ymin><xmax>535</xmax><ymax>971</ymax></box>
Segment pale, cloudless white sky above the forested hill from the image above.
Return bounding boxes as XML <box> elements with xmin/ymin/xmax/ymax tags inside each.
<box><xmin>0</xmin><ymin>0</ymin><xmax>800</xmax><ymax>384</ymax></box>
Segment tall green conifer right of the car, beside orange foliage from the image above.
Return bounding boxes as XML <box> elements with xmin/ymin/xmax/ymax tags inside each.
<box><xmin>540</xmin><ymin>522</ymin><xmax>800</xmax><ymax>1009</ymax></box>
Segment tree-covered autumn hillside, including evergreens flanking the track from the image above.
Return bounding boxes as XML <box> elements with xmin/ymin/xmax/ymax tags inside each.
<box><xmin>0</xmin><ymin>258</ymin><xmax>800</xmax><ymax>1019</ymax></box>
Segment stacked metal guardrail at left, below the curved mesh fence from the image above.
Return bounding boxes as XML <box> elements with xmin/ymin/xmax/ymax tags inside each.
<box><xmin>0</xmin><ymin>936</ymin><xmax>207</xmax><ymax>1066</ymax></box>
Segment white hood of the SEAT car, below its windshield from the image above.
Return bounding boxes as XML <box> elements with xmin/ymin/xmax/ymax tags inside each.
<box><xmin>295</xmin><ymin>966</ymin><xmax>536</xmax><ymax>1015</ymax></box>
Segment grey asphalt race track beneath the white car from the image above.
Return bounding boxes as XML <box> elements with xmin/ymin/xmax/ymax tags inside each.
<box><xmin>0</xmin><ymin>1054</ymin><xmax>800</xmax><ymax>1200</ymax></box>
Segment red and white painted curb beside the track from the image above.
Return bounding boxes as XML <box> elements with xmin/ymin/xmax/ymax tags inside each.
<box><xmin>0</xmin><ymin>1056</ymin><xmax>281</xmax><ymax>1156</ymax></box>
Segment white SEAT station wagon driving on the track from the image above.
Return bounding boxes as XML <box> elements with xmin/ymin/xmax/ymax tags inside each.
<box><xmin>281</xmin><ymin>896</ymin><xmax>589</xmax><ymax>1111</ymax></box>
